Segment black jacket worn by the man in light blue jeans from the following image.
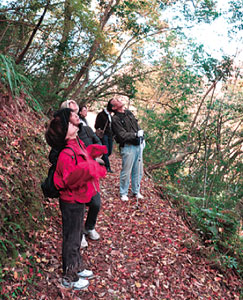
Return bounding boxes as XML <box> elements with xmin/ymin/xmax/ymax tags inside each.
<box><xmin>112</xmin><ymin>110</ymin><xmax>141</xmax><ymax>147</ymax></box>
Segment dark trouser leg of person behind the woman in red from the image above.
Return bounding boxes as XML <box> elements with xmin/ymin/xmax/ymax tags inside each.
<box><xmin>84</xmin><ymin>193</ymin><xmax>101</xmax><ymax>230</ymax></box>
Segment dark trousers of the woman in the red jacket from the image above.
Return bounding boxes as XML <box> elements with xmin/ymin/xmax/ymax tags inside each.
<box><xmin>59</xmin><ymin>200</ymin><xmax>84</xmax><ymax>281</ymax></box>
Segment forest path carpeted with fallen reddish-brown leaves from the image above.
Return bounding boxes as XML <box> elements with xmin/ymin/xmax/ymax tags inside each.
<box><xmin>32</xmin><ymin>153</ymin><xmax>240</xmax><ymax>300</ymax></box>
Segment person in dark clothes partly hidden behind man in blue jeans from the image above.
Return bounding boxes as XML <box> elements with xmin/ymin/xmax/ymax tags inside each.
<box><xmin>94</xmin><ymin>104</ymin><xmax>113</xmax><ymax>173</ymax></box>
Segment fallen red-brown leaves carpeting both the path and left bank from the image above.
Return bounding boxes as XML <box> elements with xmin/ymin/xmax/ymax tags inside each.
<box><xmin>0</xmin><ymin>103</ymin><xmax>241</xmax><ymax>300</ymax></box>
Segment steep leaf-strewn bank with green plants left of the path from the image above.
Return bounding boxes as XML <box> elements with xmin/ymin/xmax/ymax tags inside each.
<box><xmin>0</xmin><ymin>95</ymin><xmax>54</xmax><ymax>299</ymax></box>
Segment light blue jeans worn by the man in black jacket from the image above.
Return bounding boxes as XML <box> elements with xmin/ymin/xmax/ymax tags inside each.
<box><xmin>120</xmin><ymin>144</ymin><xmax>143</xmax><ymax>196</ymax></box>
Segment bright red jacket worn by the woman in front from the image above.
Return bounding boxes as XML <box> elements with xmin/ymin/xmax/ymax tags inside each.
<box><xmin>54</xmin><ymin>139</ymin><xmax>107</xmax><ymax>203</ymax></box>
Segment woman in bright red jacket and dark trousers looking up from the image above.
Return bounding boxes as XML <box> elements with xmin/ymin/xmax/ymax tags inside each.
<box><xmin>45</xmin><ymin>108</ymin><xmax>107</xmax><ymax>290</ymax></box>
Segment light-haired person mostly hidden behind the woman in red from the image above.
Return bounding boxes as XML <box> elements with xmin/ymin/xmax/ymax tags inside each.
<box><xmin>61</xmin><ymin>100</ymin><xmax>103</xmax><ymax>248</ymax></box>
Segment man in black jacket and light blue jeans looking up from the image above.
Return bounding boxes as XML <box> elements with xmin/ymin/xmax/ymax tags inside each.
<box><xmin>107</xmin><ymin>99</ymin><xmax>144</xmax><ymax>201</ymax></box>
